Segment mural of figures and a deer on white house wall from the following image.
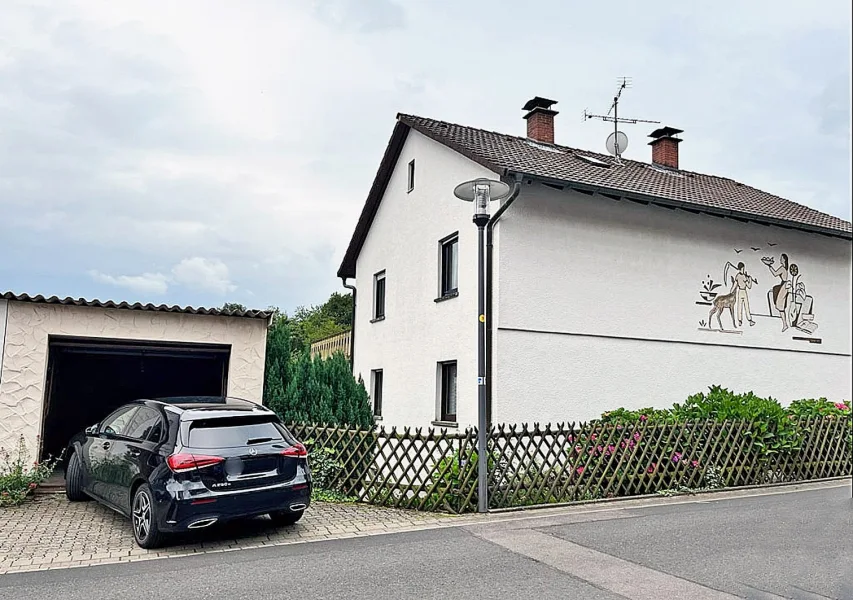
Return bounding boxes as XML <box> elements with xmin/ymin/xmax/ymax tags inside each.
<box><xmin>696</xmin><ymin>242</ymin><xmax>821</xmax><ymax>344</ymax></box>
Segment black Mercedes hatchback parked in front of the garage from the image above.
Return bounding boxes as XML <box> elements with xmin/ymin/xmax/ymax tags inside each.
<box><xmin>65</xmin><ymin>397</ymin><xmax>311</xmax><ymax>548</ymax></box>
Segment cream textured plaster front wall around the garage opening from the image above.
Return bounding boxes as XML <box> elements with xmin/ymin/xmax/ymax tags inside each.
<box><xmin>0</xmin><ymin>301</ymin><xmax>267</xmax><ymax>455</ymax></box>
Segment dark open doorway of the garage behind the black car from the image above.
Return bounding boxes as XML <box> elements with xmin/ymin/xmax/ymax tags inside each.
<box><xmin>41</xmin><ymin>338</ymin><xmax>231</xmax><ymax>458</ymax></box>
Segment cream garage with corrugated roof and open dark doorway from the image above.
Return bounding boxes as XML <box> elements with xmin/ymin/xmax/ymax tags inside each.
<box><xmin>0</xmin><ymin>292</ymin><xmax>270</xmax><ymax>457</ymax></box>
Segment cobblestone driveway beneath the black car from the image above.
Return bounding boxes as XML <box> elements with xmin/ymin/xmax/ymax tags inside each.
<box><xmin>0</xmin><ymin>494</ymin><xmax>458</xmax><ymax>574</ymax></box>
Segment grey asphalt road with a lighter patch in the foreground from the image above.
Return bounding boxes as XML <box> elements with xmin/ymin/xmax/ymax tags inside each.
<box><xmin>0</xmin><ymin>481</ymin><xmax>853</xmax><ymax>600</ymax></box>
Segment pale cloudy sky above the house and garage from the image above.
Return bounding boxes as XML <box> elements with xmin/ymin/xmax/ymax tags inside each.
<box><xmin>0</xmin><ymin>0</ymin><xmax>851</xmax><ymax>310</ymax></box>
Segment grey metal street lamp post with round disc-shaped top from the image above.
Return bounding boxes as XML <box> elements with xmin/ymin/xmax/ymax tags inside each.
<box><xmin>453</xmin><ymin>179</ymin><xmax>510</xmax><ymax>513</ymax></box>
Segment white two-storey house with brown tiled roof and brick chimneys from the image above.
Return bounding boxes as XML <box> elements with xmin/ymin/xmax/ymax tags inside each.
<box><xmin>338</xmin><ymin>97</ymin><xmax>851</xmax><ymax>427</ymax></box>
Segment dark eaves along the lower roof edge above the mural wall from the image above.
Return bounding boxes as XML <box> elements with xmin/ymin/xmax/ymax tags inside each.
<box><xmin>507</xmin><ymin>169</ymin><xmax>853</xmax><ymax>240</ymax></box>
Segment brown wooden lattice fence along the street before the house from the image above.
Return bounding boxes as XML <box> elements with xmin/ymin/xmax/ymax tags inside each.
<box><xmin>290</xmin><ymin>417</ymin><xmax>853</xmax><ymax>513</ymax></box>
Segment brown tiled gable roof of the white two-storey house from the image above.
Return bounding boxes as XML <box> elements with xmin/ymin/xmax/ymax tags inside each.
<box><xmin>338</xmin><ymin>114</ymin><xmax>853</xmax><ymax>277</ymax></box>
